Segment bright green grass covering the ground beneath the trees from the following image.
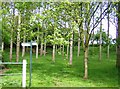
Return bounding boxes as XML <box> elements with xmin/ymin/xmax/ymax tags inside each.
<box><xmin>2</xmin><ymin>47</ymin><xmax>118</xmax><ymax>87</ymax></box>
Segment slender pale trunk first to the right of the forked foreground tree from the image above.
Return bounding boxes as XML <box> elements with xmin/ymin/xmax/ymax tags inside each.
<box><xmin>99</xmin><ymin>4</ymin><xmax>102</xmax><ymax>60</ymax></box>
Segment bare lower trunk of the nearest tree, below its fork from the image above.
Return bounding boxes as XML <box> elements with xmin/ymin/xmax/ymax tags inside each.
<box><xmin>84</xmin><ymin>47</ymin><xmax>88</xmax><ymax>79</ymax></box>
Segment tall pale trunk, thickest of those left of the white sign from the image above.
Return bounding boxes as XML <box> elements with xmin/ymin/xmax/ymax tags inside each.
<box><xmin>16</xmin><ymin>15</ymin><xmax>21</xmax><ymax>62</ymax></box>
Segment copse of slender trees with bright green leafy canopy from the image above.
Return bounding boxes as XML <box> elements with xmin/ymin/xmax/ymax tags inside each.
<box><xmin>3</xmin><ymin>1</ymin><xmax>118</xmax><ymax>79</ymax></box>
